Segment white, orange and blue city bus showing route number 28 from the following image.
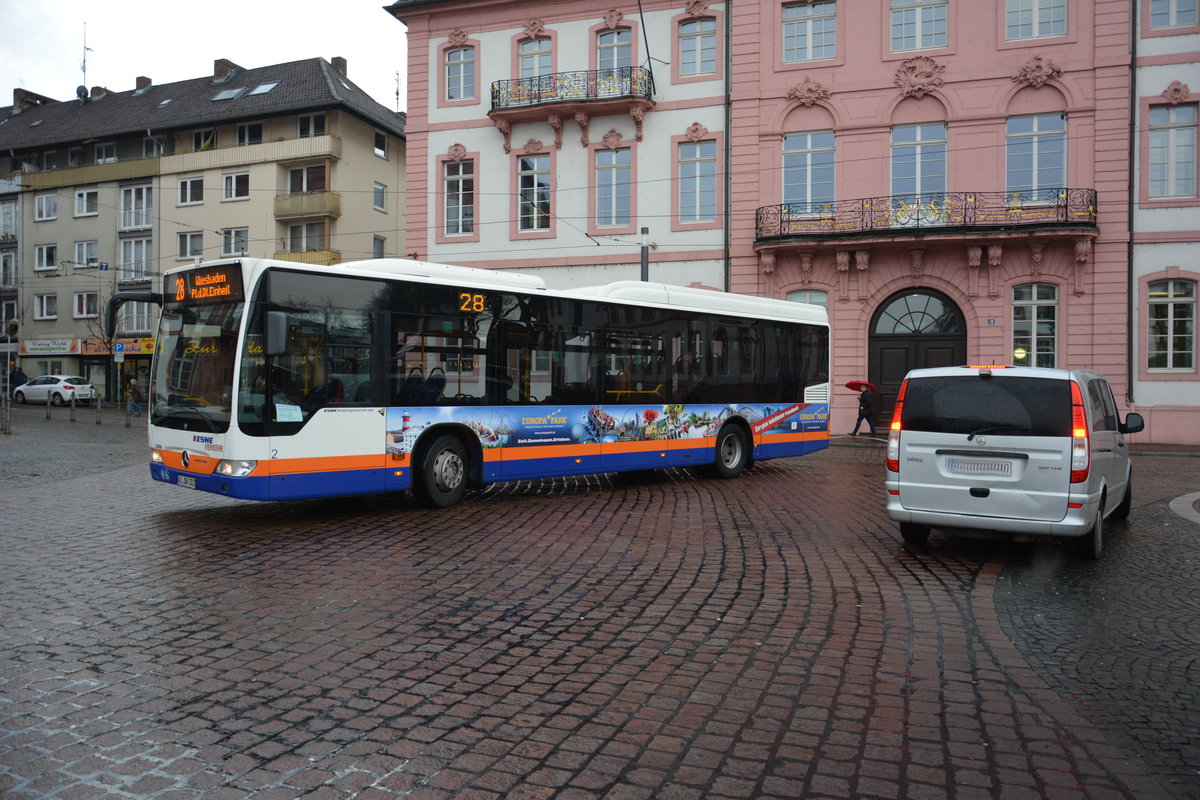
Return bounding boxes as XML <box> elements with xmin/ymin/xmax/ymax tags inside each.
<box><xmin>131</xmin><ymin>258</ymin><xmax>829</xmax><ymax>507</ymax></box>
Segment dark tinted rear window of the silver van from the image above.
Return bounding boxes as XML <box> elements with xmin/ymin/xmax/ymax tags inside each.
<box><xmin>900</xmin><ymin>374</ymin><xmax>1070</xmax><ymax>437</ymax></box>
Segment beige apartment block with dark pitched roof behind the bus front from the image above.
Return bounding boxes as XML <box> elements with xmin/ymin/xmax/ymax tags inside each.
<box><xmin>0</xmin><ymin>58</ymin><xmax>404</xmax><ymax>398</ymax></box>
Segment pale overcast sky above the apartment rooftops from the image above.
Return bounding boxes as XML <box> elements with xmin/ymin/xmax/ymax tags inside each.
<box><xmin>0</xmin><ymin>0</ymin><xmax>408</xmax><ymax>110</ymax></box>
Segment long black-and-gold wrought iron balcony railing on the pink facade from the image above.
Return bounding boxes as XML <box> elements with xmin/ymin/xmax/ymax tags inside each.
<box><xmin>755</xmin><ymin>188</ymin><xmax>1096</xmax><ymax>241</ymax></box>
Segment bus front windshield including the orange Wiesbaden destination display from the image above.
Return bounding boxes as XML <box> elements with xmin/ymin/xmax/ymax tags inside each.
<box><xmin>150</xmin><ymin>266</ymin><xmax>244</xmax><ymax>433</ymax></box>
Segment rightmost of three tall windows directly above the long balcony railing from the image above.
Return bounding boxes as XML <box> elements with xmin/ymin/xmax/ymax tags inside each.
<box><xmin>1006</xmin><ymin>113</ymin><xmax>1067</xmax><ymax>203</ymax></box>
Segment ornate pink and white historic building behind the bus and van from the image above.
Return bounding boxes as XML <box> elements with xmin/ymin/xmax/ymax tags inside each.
<box><xmin>389</xmin><ymin>0</ymin><xmax>1200</xmax><ymax>443</ymax></box>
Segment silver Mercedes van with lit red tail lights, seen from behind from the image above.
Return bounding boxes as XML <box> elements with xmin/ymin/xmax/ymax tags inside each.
<box><xmin>887</xmin><ymin>365</ymin><xmax>1144</xmax><ymax>558</ymax></box>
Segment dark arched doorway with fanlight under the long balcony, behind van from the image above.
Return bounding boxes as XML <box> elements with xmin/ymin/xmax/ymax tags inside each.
<box><xmin>866</xmin><ymin>287</ymin><xmax>967</xmax><ymax>429</ymax></box>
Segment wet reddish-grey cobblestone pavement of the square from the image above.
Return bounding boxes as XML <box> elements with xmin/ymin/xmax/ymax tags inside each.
<box><xmin>0</xmin><ymin>409</ymin><xmax>1200</xmax><ymax>800</ymax></box>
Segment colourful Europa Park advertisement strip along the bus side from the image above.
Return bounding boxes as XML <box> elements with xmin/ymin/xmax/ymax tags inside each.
<box><xmin>386</xmin><ymin>403</ymin><xmax>829</xmax><ymax>453</ymax></box>
